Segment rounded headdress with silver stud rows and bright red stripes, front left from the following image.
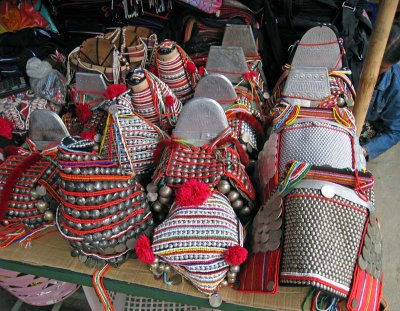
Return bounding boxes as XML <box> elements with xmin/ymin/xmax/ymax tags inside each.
<box><xmin>56</xmin><ymin>137</ymin><xmax>152</xmax><ymax>268</ymax></box>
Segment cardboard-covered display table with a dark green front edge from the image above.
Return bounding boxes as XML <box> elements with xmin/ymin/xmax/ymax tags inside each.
<box><xmin>0</xmin><ymin>233</ymin><xmax>309</xmax><ymax>311</ymax></box>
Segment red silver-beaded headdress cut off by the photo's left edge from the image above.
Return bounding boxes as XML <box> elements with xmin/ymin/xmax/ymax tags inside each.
<box><xmin>0</xmin><ymin>148</ymin><xmax>59</xmax><ymax>229</ymax></box>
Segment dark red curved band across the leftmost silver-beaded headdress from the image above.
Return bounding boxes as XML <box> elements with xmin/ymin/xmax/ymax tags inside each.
<box><xmin>0</xmin><ymin>152</ymin><xmax>42</xmax><ymax>219</ymax></box>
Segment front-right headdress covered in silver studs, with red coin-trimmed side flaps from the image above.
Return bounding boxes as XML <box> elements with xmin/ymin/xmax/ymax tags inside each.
<box><xmin>241</xmin><ymin>162</ymin><xmax>383</xmax><ymax>310</ymax></box>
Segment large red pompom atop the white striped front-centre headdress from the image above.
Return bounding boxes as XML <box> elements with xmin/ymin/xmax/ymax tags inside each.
<box><xmin>175</xmin><ymin>179</ymin><xmax>211</xmax><ymax>206</ymax></box>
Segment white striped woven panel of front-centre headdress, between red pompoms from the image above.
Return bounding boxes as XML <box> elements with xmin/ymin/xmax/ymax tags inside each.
<box><xmin>152</xmin><ymin>192</ymin><xmax>244</xmax><ymax>294</ymax></box>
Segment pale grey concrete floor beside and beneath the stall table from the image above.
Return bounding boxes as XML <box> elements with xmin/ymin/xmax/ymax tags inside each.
<box><xmin>0</xmin><ymin>144</ymin><xmax>400</xmax><ymax>311</ymax></box>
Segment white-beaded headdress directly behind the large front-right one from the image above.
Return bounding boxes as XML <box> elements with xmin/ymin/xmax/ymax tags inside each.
<box><xmin>256</xmin><ymin>105</ymin><xmax>366</xmax><ymax>199</ymax></box>
